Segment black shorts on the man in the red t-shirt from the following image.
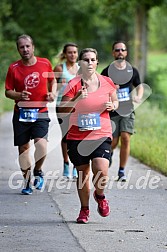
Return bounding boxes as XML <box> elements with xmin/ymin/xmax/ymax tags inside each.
<box><xmin>13</xmin><ymin>111</ymin><xmax>50</xmax><ymax>146</ymax></box>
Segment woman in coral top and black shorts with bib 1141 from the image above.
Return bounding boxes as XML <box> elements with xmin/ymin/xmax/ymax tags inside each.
<box><xmin>59</xmin><ymin>48</ymin><xmax>118</xmax><ymax>223</ymax></box>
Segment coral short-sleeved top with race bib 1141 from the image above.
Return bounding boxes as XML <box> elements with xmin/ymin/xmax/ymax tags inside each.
<box><xmin>64</xmin><ymin>74</ymin><xmax>115</xmax><ymax>140</ymax></box>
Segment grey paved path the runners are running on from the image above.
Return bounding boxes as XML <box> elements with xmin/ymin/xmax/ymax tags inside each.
<box><xmin>0</xmin><ymin>111</ymin><xmax>167</xmax><ymax>252</ymax></box>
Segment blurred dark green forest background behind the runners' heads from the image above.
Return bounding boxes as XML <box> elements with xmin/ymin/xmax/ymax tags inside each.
<box><xmin>0</xmin><ymin>0</ymin><xmax>167</xmax><ymax>85</ymax></box>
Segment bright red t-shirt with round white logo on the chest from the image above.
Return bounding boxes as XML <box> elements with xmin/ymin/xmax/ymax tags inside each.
<box><xmin>5</xmin><ymin>57</ymin><xmax>54</xmax><ymax>111</ymax></box>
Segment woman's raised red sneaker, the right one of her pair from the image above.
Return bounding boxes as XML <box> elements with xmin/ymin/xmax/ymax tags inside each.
<box><xmin>93</xmin><ymin>191</ymin><xmax>110</xmax><ymax>217</ymax></box>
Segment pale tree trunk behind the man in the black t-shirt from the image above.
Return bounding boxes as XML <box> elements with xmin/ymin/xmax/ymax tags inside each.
<box><xmin>134</xmin><ymin>5</ymin><xmax>147</xmax><ymax>82</ymax></box>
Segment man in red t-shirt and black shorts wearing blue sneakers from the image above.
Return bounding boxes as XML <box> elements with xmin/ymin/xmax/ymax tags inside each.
<box><xmin>5</xmin><ymin>34</ymin><xmax>57</xmax><ymax>195</ymax></box>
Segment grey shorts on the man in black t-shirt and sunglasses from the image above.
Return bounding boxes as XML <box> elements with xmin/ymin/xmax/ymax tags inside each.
<box><xmin>110</xmin><ymin>112</ymin><xmax>135</xmax><ymax>137</ymax></box>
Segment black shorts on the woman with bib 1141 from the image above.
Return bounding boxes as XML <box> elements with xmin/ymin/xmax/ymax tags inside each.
<box><xmin>67</xmin><ymin>138</ymin><xmax>111</xmax><ymax>166</ymax></box>
